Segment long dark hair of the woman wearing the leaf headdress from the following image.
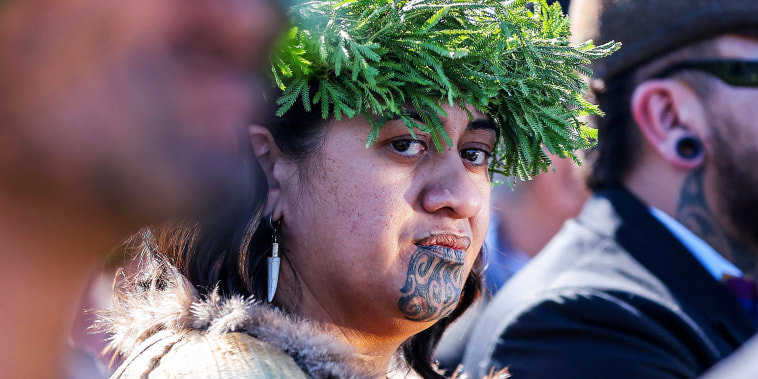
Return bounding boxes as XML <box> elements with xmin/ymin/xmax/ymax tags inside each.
<box><xmin>143</xmin><ymin>86</ymin><xmax>483</xmax><ymax>378</ymax></box>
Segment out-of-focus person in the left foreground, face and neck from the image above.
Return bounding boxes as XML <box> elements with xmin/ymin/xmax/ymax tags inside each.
<box><xmin>0</xmin><ymin>0</ymin><xmax>282</xmax><ymax>378</ymax></box>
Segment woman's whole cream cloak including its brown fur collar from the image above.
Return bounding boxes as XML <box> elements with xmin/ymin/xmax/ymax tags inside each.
<box><xmin>95</xmin><ymin>255</ymin><xmax>508</xmax><ymax>379</ymax></box>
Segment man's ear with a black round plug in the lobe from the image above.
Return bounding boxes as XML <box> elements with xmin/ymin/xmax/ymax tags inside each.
<box><xmin>631</xmin><ymin>79</ymin><xmax>705</xmax><ymax>171</ymax></box>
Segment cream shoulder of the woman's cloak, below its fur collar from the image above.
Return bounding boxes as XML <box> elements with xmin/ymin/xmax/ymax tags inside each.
<box><xmin>113</xmin><ymin>330</ymin><xmax>307</xmax><ymax>379</ymax></box>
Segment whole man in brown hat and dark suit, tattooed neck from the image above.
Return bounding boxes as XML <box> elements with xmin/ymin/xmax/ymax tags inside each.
<box><xmin>464</xmin><ymin>0</ymin><xmax>758</xmax><ymax>378</ymax></box>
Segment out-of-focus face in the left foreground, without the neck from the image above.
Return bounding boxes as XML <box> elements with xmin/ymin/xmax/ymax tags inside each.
<box><xmin>0</xmin><ymin>0</ymin><xmax>283</xmax><ymax>226</ymax></box>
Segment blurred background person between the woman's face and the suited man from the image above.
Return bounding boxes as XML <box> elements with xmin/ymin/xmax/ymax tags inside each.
<box><xmin>435</xmin><ymin>156</ymin><xmax>589</xmax><ymax>370</ymax></box>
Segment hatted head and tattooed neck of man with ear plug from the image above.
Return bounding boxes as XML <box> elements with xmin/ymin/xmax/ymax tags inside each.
<box><xmin>570</xmin><ymin>0</ymin><xmax>758</xmax><ymax>268</ymax></box>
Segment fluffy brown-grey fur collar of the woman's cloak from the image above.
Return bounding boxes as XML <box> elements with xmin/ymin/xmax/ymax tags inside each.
<box><xmin>96</xmin><ymin>257</ymin><xmax>386</xmax><ymax>378</ymax></box>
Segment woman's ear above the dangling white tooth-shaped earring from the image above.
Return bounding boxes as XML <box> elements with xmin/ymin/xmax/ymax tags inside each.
<box><xmin>248</xmin><ymin>125</ymin><xmax>283</xmax><ymax>220</ymax></box>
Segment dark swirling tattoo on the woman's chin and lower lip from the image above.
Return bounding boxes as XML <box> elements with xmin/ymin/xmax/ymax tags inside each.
<box><xmin>397</xmin><ymin>246</ymin><xmax>466</xmax><ymax>321</ymax></box>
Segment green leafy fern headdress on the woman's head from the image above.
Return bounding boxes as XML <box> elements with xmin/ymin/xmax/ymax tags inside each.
<box><xmin>272</xmin><ymin>0</ymin><xmax>618</xmax><ymax>178</ymax></box>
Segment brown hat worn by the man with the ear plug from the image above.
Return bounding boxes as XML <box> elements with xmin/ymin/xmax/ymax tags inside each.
<box><xmin>569</xmin><ymin>0</ymin><xmax>758</xmax><ymax>81</ymax></box>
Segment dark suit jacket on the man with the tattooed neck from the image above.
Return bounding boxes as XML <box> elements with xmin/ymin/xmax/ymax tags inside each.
<box><xmin>464</xmin><ymin>189</ymin><xmax>756</xmax><ymax>379</ymax></box>
